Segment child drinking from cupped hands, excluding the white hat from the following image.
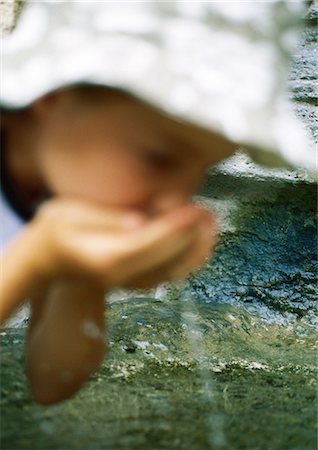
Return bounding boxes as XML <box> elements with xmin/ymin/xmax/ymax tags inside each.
<box><xmin>0</xmin><ymin>85</ymin><xmax>235</xmax><ymax>403</ymax></box>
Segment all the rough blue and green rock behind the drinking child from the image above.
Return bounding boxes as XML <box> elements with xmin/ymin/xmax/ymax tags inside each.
<box><xmin>1</xmin><ymin>4</ymin><xmax>317</xmax><ymax>450</ymax></box>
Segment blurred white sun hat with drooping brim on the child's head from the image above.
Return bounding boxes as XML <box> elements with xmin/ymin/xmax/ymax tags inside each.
<box><xmin>1</xmin><ymin>0</ymin><xmax>316</xmax><ymax>171</ymax></box>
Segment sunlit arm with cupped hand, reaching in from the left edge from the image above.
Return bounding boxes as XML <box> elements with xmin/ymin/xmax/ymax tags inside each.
<box><xmin>0</xmin><ymin>199</ymin><xmax>215</xmax><ymax>321</ymax></box>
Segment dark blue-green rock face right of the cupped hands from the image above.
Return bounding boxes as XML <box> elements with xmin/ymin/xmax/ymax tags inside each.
<box><xmin>191</xmin><ymin>174</ymin><xmax>318</xmax><ymax>325</ymax></box>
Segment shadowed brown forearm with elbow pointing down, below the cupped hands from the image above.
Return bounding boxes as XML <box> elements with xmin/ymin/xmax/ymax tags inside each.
<box><xmin>27</xmin><ymin>279</ymin><xmax>105</xmax><ymax>403</ymax></box>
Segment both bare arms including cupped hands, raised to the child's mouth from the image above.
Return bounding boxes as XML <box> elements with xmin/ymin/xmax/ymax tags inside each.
<box><xmin>1</xmin><ymin>201</ymin><xmax>213</xmax><ymax>403</ymax></box>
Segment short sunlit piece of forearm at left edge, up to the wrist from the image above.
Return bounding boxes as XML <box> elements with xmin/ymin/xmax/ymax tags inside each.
<box><xmin>0</xmin><ymin>226</ymin><xmax>44</xmax><ymax>323</ymax></box>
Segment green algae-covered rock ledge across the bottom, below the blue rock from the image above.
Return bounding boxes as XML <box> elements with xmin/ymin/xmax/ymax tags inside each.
<box><xmin>1</xmin><ymin>298</ymin><xmax>317</xmax><ymax>450</ymax></box>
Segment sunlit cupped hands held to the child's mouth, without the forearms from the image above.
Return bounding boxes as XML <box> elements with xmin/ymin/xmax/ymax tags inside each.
<box><xmin>32</xmin><ymin>199</ymin><xmax>215</xmax><ymax>288</ymax></box>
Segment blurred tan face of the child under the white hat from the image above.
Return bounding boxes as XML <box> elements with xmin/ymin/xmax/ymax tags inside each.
<box><xmin>34</xmin><ymin>94</ymin><xmax>211</xmax><ymax>214</ymax></box>
